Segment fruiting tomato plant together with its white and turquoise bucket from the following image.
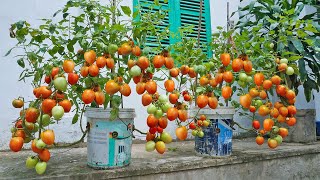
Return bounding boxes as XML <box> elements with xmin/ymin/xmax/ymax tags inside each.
<box><xmin>6</xmin><ymin>0</ymin><xmax>166</xmax><ymax>174</ymax></box>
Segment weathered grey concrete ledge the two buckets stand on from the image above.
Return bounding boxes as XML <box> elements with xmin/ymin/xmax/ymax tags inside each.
<box><xmin>0</xmin><ymin>138</ymin><xmax>320</xmax><ymax>180</ymax></box>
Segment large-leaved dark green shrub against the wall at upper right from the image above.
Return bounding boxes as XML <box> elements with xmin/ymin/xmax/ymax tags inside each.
<box><xmin>233</xmin><ymin>0</ymin><xmax>320</xmax><ymax>101</ymax></box>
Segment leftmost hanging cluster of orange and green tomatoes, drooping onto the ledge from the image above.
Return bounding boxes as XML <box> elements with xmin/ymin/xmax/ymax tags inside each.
<box><xmin>9</xmin><ymin>60</ymin><xmax>79</xmax><ymax>174</ymax></box>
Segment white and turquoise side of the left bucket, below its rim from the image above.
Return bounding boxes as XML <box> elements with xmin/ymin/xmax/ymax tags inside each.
<box><xmin>88</xmin><ymin>120</ymin><xmax>133</xmax><ymax>168</ymax></box>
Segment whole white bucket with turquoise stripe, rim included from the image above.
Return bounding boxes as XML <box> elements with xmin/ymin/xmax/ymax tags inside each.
<box><xmin>85</xmin><ymin>108</ymin><xmax>135</xmax><ymax>169</ymax></box>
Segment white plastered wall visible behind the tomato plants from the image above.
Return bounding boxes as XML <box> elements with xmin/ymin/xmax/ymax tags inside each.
<box><xmin>0</xmin><ymin>0</ymin><xmax>318</xmax><ymax>149</ymax></box>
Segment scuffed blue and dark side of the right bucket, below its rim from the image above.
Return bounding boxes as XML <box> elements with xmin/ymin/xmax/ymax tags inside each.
<box><xmin>195</xmin><ymin>119</ymin><xmax>232</xmax><ymax>156</ymax></box>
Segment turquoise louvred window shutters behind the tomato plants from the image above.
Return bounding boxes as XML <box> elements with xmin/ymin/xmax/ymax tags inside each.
<box><xmin>133</xmin><ymin>0</ymin><xmax>212</xmax><ymax>57</ymax></box>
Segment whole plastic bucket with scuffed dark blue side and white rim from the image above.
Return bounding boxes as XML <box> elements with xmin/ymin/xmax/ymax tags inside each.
<box><xmin>191</xmin><ymin>107</ymin><xmax>235</xmax><ymax>156</ymax></box>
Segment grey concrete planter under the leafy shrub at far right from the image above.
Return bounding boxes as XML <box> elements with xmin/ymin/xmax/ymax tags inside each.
<box><xmin>285</xmin><ymin>109</ymin><xmax>317</xmax><ymax>143</ymax></box>
